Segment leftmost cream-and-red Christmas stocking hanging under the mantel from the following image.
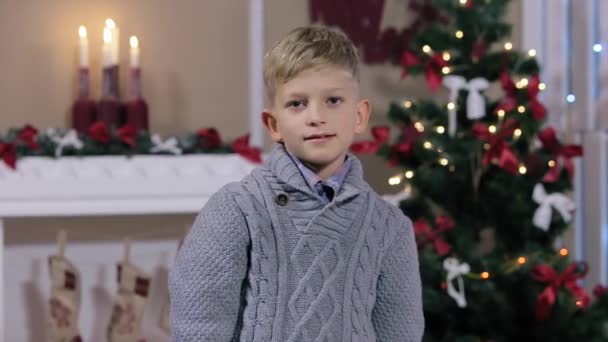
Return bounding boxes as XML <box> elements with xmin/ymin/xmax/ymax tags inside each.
<box><xmin>47</xmin><ymin>231</ymin><xmax>82</xmax><ymax>342</ymax></box>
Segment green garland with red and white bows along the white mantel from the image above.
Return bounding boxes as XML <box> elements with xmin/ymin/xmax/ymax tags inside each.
<box><xmin>0</xmin><ymin>122</ymin><xmax>261</xmax><ymax>169</ymax></box>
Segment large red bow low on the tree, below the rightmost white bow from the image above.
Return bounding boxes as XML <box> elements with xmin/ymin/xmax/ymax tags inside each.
<box><xmin>531</xmin><ymin>262</ymin><xmax>590</xmax><ymax>321</ymax></box>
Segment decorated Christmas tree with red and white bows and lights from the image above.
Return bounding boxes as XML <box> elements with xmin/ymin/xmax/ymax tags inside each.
<box><xmin>352</xmin><ymin>0</ymin><xmax>608</xmax><ymax>341</ymax></box>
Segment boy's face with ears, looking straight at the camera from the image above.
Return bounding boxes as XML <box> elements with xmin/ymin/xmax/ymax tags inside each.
<box><xmin>263</xmin><ymin>66</ymin><xmax>370</xmax><ymax>173</ymax></box>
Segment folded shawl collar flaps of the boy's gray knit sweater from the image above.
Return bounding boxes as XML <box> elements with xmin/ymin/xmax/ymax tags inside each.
<box><xmin>265</xmin><ymin>143</ymin><xmax>368</xmax><ymax>201</ymax></box>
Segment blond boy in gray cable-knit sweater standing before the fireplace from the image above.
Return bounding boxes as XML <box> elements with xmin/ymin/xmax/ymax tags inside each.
<box><xmin>170</xmin><ymin>26</ymin><xmax>424</xmax><ymax>342</ymax></box>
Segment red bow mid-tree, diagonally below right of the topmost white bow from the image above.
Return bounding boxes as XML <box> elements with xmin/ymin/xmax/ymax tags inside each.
<box><xmin>472</xmin><ymin>119</ymin><xmax>519</xmax><ymax>174</ymax></box>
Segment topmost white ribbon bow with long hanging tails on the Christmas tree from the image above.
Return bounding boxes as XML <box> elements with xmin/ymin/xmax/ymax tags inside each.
<box><xmin>443</xmin><ymin>75</ymin><xmax>490</xmax><ymax>137</ymax></box>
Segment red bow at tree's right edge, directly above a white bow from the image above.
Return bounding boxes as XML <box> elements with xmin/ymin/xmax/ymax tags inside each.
<box><xmin>538</xmin><ymin>127</ymin><xmax>583</xmax><ymax>183</ymax></box>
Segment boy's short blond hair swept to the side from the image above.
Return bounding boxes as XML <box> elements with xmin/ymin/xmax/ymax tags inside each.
<box><xmin>264</xmin><ymin>25</ymin><xmax>359</xmax><ymax>104</ymax></box>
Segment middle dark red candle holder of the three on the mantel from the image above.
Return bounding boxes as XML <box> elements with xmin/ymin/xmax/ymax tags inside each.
<box><xmin>97</xmin><ymin>65</ymin><xmax>124</xmax><ymax>128</ymax></box>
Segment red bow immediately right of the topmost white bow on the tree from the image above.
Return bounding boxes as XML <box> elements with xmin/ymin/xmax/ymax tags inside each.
<box><xmin>497</xmin><ymin>71</ymin><xmax>547</xmax><ymax>121</ymax></box>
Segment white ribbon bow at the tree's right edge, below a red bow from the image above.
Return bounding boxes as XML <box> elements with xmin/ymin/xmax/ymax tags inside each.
<box><xmin>532</xmin><ymin>183</ymin><xmax>576</xmax><ymax>231</ymax></box>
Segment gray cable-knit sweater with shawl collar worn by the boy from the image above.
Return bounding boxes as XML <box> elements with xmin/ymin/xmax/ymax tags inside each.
<box><xmin>169</xmin><ymin>144</ymin><xmax>424</xmax><ymax>342</ymax></box>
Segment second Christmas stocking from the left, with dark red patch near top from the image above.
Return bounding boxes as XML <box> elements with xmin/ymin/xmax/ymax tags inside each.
<box><xmin>108</xmin><ymin>241</ymin><xmax>150</xmax><ymax>342</ymax></box>
